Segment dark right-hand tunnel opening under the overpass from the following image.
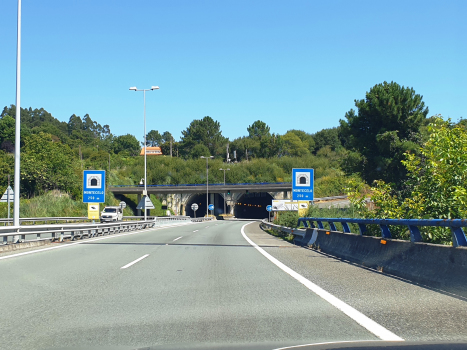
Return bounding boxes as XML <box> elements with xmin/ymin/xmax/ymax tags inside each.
<box><xmin>234</xmin><ymin>192</ymin><xmax>273</xmax><ymax>219</ymax></box>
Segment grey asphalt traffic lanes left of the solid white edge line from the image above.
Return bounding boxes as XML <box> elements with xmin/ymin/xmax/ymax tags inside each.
<box><xmin>0</xmin><ymin>221</ymin><xmax>390</xmax><ymax>349</ymax></box>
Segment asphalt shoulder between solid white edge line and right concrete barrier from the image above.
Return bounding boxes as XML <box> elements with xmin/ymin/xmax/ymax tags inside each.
<box><xmin>245</xmin><ymin>223</ymin><xmax>467</xmax><ymax>340</ymax></box>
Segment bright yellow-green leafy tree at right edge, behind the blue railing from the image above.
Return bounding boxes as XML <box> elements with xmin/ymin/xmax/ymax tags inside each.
<box><xmin>349</xmin><ymin>116</ymin><xmax>467</xmax><ymax>244</ymax></box>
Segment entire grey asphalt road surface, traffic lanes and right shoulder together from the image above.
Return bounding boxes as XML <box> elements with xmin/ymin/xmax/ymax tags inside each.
<box><xmin>0</xmin><ymin>221</ymin><xmax>467</xmax><ymax>349</ymax></box>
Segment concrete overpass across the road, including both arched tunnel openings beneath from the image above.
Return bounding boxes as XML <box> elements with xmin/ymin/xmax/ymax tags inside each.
<box><xmin>109</xmin><ymin>182</ymin><xmax>292</xmax><ymax>218</ymax></box>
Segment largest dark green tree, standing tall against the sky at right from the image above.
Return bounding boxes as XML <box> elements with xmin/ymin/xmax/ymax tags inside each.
<box><xmin>338</xmin><ymin>82</ymin><xmax>428</xmax><ymax>187</ymax></box>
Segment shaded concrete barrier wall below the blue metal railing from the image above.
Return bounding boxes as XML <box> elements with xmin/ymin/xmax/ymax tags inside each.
<box><xmin>308</xmin><ymin>229</ymin><xmax>467</xmax><ymax>298</ymax></box>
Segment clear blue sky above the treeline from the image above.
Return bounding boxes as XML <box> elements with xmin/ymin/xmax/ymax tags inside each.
<box><xmin>0</xmin><ymin>0</ymin><xmax>467</xmax><ymax>139</ymax></box>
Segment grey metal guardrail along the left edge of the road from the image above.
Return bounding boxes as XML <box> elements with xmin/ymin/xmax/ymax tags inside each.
<box><xmin>0</xmin><ymin>216</ymin><xmax>191</xmax><ymax>244</ymax></box>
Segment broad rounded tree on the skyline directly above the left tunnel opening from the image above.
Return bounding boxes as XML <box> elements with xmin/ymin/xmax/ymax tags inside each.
<box><xmin>180</xmin><ymin>116</ymin><xmax>228</xmax><ymax>157</ymax></box>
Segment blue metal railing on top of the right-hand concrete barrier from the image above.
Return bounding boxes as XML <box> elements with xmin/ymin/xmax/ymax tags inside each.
<box><xmin>298</xmin><ymin>218</ymin><xmax>467</xmax><ymax>247</ymax></box>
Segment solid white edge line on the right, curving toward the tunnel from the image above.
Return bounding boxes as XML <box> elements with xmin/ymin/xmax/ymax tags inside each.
<box><xmin>241</xmin><ymin>222</ymin><xmax>404</xmax><ymax>341</ymax></box>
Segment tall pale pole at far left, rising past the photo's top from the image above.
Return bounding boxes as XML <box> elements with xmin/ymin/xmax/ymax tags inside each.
<box><xmin>13</xmin><ymin>0</ymin><xmax>21</xmax><ymax>228</ymax></box>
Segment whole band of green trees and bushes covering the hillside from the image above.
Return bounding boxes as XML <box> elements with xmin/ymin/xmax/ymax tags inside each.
<box><xmin>0</xmin><ymin>82</ymin><xmax>467</xmax><ymax>230</ymax></box>
